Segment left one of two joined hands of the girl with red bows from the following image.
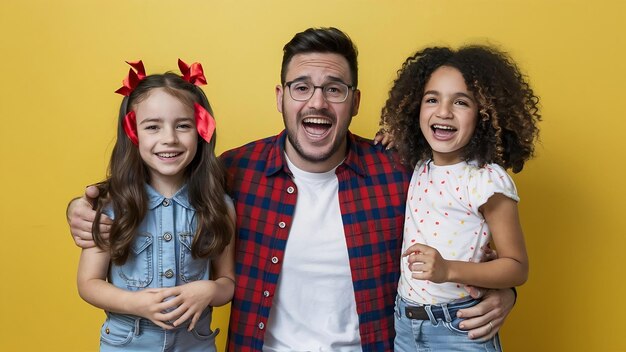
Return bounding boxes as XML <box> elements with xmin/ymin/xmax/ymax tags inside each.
<box><xmin>130</xmin><ymin>288</ymin><xmax>176</xmax><ymax>330</ymax></box>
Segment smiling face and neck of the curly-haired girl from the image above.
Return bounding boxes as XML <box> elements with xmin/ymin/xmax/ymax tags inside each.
<box><xmin>419</xmin><ymin>66</ymin><xmax>478</xmax><ymax>165</ymax></box>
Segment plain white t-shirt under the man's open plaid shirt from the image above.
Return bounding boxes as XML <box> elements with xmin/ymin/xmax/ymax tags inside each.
<box><xmin>263</xmin><ymin>159</ymin><xmax>361</xmax><ymax>352</ymax></box>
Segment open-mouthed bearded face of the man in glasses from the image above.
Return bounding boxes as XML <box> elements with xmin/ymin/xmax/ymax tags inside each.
<box><xmin>276</xmin><ymin>53</ymin><xmax>361</xmax><ymax>172</ymax></box>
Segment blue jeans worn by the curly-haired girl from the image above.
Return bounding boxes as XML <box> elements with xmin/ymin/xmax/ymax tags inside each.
<box><xmin>394</xmin><ymin>296</ymin><xmax>502</xmax><ymax>352</ymax></box>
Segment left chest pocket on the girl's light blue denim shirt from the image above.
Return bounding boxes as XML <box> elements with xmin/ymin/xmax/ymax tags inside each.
<box><xmin>119</xmin><ymin>232</ymin><xmax>153</xmax><ymax>291</ymax></box>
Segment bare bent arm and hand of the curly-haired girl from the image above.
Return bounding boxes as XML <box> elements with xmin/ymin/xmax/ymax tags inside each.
<box><xmin>404</xmin><ymin>193</ymin><xmax>528</xmax><ymax>288</ymax></box>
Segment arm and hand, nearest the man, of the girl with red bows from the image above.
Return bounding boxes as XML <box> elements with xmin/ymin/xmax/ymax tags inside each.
<box><xmin>165</xmin><ymin>208</ymin><xmax>235</xmax><ymax>330</ymax></box>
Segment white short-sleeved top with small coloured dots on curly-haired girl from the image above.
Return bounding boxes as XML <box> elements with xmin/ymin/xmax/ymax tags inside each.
<box><xmin>398</xmin><ymin>160</ymin><xmax>519</xmax><ymax>304</ymax></box>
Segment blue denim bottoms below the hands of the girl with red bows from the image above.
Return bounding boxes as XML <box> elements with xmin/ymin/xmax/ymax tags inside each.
<box><xmin>100</xmin><ymin>311</ymin><xmax>219</xmax><ymax>352</ymax></box>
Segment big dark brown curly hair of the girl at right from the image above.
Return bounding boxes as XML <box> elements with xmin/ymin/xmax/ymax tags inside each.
<box><xmin>380</xmin><ymin>45</ymin><xmax>541</xmax><ymax>173</ymax></box>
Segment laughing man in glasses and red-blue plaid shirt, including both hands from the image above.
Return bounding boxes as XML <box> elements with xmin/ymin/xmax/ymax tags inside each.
<box><xmin>68</xmin><ymin>28</ymin><xmax>514</xmax><ymax>352</ymax></box>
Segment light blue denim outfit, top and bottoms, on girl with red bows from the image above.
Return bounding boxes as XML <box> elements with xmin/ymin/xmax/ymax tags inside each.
<box><xmin>100</xmin><ymin>185</ymin><xmax>219</xmax><ymax>352</ymax></box>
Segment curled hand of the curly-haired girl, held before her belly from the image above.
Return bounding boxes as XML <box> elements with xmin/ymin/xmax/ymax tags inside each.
<box><xmin>402</xmin><ymin>243</ymin><xmax>450</xmax><ymax>283</ymax></box>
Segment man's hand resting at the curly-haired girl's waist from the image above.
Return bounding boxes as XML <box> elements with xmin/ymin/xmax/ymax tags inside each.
<box><xmin>457</xmin><ymin>288</ymin><xmax>515</xmax><ymax>340</ymax></box>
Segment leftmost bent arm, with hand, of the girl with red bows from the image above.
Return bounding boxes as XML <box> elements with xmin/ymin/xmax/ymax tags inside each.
<box><xmin>77</xmin><ymin>247</ymin><xmax>172</xmax><ymax>329</ymax></box>
